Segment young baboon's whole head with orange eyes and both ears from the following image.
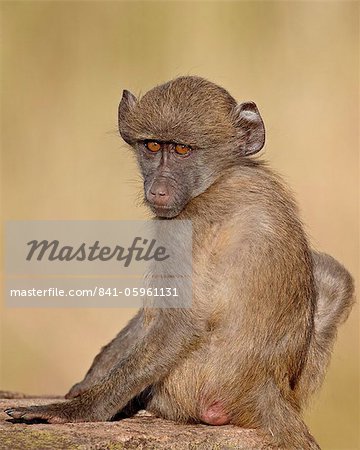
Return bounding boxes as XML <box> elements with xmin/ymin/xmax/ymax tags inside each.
<box><xmin>119</xmin><ymin>77</ymin><xmax>265</xmax><ymax>218</ymax></box>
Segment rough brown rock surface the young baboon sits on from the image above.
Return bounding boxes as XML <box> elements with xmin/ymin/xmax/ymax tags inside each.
<box><xmin>0</xmin><ymin>391</ymin><xmax>271</xmax><ymax>450</ymax></box>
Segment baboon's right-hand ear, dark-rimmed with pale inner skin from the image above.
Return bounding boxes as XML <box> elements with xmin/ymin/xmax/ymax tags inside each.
<box><xmin>236</xmin><ymin>102</ymin><xmax>265</xmax><ymax>156</ymax></box>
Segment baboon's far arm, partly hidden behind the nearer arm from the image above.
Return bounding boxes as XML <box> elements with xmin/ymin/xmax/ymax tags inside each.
<box><xmin>65</xmin><ymin>309</ymin><xmax>144</xmax><ymax>398</ymax></box>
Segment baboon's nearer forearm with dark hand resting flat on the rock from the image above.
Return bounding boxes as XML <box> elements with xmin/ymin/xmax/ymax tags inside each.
<box><xmin>6</xmin><ymin>310</ymin><xmax>200</xmax><ymax>423</ymax></box>
